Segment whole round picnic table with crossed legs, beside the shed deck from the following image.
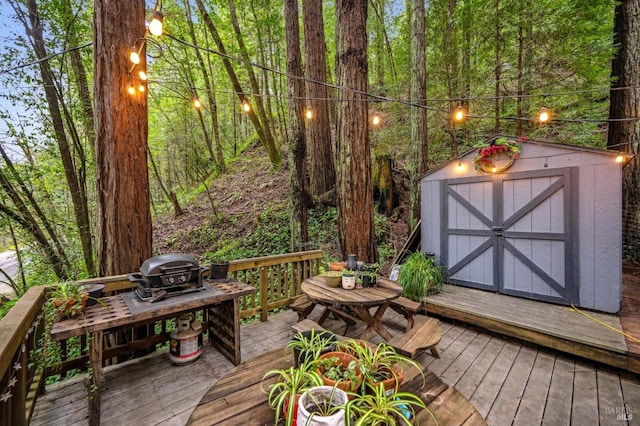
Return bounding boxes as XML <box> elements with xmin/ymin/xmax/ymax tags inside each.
<box><xmin>301</xmin><ymin>275</ymin><xmax>402</xmax><ymax>340</ymax></box>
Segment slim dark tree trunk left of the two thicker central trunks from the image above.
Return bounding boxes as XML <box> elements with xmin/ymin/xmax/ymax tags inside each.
<box><xmin>284</xmin><ymin>0</ymin><xmax>309</xmax><ymax>252</ymax></box>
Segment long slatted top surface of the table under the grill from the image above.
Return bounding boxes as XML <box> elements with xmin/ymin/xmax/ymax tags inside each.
<box><xmin>51</xmin><ymin>278</ymin><xmax>256</xmax><ymax>340</ymax></box>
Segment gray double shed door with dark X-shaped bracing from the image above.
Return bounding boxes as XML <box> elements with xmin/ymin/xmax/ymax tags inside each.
<box><xmin>441</xmin><ymin>168</ymin><xmax>578</xmax><ymax>304</ymax></box>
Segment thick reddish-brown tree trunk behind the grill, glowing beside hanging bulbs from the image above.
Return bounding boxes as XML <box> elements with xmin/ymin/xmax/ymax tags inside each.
<box><xmin>93</xmin><ymin>0</ymin><xmax>153</xmax><ymax>276</ymax></box>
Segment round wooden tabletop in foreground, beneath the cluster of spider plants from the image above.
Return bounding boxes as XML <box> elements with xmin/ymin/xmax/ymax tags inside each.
<box><xmin>187</xmin><ymin>349</ymin><xmax>486</xmax><ymax>426</ymax></box>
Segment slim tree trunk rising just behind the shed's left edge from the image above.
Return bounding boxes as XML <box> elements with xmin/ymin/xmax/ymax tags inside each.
<box><xmin>409</xmin><ymin>0</ymin><xmax>428</xmax><ymax>229</ymax></box>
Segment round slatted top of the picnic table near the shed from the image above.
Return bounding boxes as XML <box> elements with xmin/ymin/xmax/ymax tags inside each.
<box><xmin>300</xmin><ymin>275</ymin><xmax>402</xmax><ymax>307</ymax></box>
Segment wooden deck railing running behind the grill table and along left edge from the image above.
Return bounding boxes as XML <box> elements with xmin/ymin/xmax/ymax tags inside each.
<box><xmin>0</xmin><ymin>250</ymin><xmax>323</xmax><ymax>426</ymax></box>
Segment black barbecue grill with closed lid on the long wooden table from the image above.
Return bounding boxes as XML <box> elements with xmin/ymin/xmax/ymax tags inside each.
<box><xmin>127</xmin><ymin>253</ymin><xmax>208</xmax><ymax>302</ymax></box>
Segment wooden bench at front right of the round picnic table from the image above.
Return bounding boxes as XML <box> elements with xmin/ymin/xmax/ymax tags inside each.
<box><xmin>387</xmin><ymin>315</ymin><xmax>442</xmax><ymax>359</ymax></box>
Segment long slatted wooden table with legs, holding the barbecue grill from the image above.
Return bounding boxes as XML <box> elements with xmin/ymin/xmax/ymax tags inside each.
<box><xmin>51</xmin><ymin>279</ymin><xmax>256</xmax><ymax>424</ymax></box>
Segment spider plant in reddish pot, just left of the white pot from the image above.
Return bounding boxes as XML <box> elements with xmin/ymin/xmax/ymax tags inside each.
<box><xmin>262</xmin><ymin>363</ymin><xmax>322</xmax><ymax>425</ymax></box>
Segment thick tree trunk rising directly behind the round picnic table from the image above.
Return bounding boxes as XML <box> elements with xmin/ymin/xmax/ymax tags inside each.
<box><xmin>336</xmin><ymin>0</ymin><xmax>378</xmax><ymax>262</ymax></box>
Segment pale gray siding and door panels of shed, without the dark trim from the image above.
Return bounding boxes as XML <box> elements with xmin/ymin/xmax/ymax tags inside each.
<box><xmin>421</xmin><ymin>142</ymin><xmax>622</xmax><ymax>312</ymax></box>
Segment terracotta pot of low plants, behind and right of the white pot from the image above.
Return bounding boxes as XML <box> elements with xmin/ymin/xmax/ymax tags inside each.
<box><xmin>316</xmin><ymin>352</ymin><xmax>363</xmax><ymax>392</ymax></box>
